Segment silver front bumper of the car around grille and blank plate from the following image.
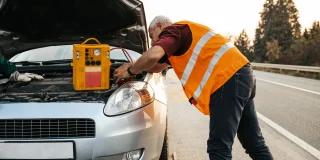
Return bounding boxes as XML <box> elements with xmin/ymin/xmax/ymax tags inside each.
<box><xmin>0</xmin><ymin>100</ymin><xmax>167</xmax><ymax>160</ymax></box>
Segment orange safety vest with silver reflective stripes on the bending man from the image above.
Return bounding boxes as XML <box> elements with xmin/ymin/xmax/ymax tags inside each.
<box><xmin>169</xmin><ymin>21</ymin><xmax>249</xmax><ymax>115</ymax></box>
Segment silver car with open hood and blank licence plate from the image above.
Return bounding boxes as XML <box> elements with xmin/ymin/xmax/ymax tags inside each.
<box><xmin>0</xmin><ymin>0</ymin><xmax>168</xmax><ymax>160</ymax></box>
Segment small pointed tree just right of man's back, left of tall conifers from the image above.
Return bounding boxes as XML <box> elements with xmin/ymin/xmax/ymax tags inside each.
<box><xmin>234</xmin><ymin>29</ymin><xmax>254</xmax><ymax>61</ymax></box>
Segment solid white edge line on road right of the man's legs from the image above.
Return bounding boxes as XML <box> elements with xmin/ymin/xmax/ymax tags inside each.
<box><xmin>257</xmin><ymin>112</ymin><xmax>320</xmax><ymax>159</ymax></box>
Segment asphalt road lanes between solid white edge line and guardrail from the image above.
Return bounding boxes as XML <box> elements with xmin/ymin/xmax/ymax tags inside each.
<box><xmin>255</xmin><ymin>71</ymin><xmax>320</xmax><ymax>150</ymax></box>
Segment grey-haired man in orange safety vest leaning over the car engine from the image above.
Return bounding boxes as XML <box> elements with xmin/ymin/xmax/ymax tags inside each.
<box><xmin>114</xmin><ymin>16</ymin><xmax>273</xmax><ymax>160</ymax></box>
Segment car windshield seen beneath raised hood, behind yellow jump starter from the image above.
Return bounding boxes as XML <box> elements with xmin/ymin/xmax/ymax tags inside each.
<box><xmin>10</xmin><ymin>45</ymin><xmax>141</xmax><ymax>62</ymax></box>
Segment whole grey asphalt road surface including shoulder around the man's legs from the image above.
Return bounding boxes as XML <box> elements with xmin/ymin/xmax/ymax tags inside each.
<box><xmin>166</xmin><ymin>70</ymin><xmax>320</xmax><ymax>160</ymax></box>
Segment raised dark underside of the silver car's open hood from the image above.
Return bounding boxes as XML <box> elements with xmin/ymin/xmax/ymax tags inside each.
<box><xmin>0</xmin><ymin>0</ymin><xmax>149</xmax><ymax>58</ymax></box>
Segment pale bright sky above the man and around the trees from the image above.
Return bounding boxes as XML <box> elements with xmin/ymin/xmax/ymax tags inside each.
<box><xmin>142</xmin><ymin>0</ymin><xmax>320</xmax><ymax>40</ymax></box>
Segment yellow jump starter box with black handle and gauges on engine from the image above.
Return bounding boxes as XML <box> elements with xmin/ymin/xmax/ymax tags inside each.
<box><xmin>72</xmin><ymin>38</ymin><xmax>111</xmax><ymax>91</ymax></box>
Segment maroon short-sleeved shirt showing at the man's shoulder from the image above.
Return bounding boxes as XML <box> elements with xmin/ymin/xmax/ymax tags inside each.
<box><xmin>155</xmin><ymin>24</ymin><xmax>192</xmax><ymax>64</ymax></box>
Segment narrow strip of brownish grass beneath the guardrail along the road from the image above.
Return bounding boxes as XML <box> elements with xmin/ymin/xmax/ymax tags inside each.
<box><xmin>253</xmin><ymin>67</ymin><xmax>320</xmax><ymax>80</ymax></box>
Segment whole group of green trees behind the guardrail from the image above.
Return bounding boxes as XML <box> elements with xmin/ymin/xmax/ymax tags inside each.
<box><xmin>241</xmin><ymin>0</ymin><xmax>320</xmax><ymax>66</ymax></box>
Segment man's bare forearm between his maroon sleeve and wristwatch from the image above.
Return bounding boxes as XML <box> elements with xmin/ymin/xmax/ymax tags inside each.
<box><xmin>130</xmin><ymin>46</ymin><xmax>165</xmax><ymax>74</ymax></box>
